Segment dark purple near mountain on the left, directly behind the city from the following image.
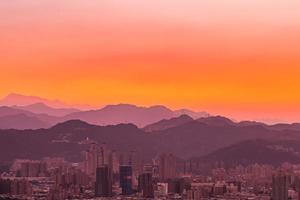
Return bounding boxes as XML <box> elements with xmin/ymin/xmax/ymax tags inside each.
<box><xmin>0</xmin><ymin>120</ymin><xmax>154</xmax><ymax>162</ymax></box>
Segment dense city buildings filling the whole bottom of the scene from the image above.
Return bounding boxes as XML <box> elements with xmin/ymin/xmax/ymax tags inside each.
<box><xmin>0</xmin><ymin>142</ymin><xmax>300</xmax><ymax>200</ymax></box>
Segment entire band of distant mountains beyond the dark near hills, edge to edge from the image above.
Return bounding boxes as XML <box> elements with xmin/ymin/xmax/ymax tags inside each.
<box><xmin>0</xmin><ymin>94</ymin><xmax>300</xmax><ymax>132</ymax></box>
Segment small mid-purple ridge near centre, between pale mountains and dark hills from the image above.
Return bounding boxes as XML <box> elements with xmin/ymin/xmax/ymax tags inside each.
<box><xmin>143</xmin><ymin>115</ymin><xmax>194</xmax><ymax>132</ymax></box>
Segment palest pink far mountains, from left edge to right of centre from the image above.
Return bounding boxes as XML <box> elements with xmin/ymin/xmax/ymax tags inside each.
<box><xmin>0</xmin><ymin>94</ymin><xmax>209</xmax><ymax>129</ymax></box>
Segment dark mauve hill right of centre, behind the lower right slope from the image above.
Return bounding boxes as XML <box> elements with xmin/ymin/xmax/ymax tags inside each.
<box><xmin>150</xmin><ymin>120</ymin><xmax>281</xmax><ymax>158</ymax></box>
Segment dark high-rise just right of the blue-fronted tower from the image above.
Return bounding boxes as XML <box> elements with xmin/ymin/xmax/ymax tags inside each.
<box><xmin>138</xmin><ymin>173</ymin><xmax>154</xmax><ymax>198</ymax></box>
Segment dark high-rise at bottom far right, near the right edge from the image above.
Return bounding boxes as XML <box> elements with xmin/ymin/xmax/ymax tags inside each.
<box><xmin>272</xmin><ymin>170</ymin><xmax>289</xmax><ymax>200</ymax></box>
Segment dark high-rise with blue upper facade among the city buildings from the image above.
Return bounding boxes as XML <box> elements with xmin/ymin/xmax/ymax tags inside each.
<box><xmin>120</xmin><ymin>165</ymin><xmax>132</xmax><ymax>195</ymax></box>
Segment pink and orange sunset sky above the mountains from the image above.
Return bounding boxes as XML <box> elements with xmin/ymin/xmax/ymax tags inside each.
<box><xmin>0</xmin><ymin>0</ymin><xmax>300</xmax><ymax>122</ymax></box>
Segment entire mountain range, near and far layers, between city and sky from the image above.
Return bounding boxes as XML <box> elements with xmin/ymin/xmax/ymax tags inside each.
<box><xmin>0</xmin><ymin>92</ymin><xmax>300</xmax><ymax>170</ymax></box>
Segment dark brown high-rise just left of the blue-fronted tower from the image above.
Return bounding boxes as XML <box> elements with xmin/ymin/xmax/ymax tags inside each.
<box><xmin>95</xmin><ymin>165</ymin><xmax>112</xmax><ymax>197</ymax></box>
